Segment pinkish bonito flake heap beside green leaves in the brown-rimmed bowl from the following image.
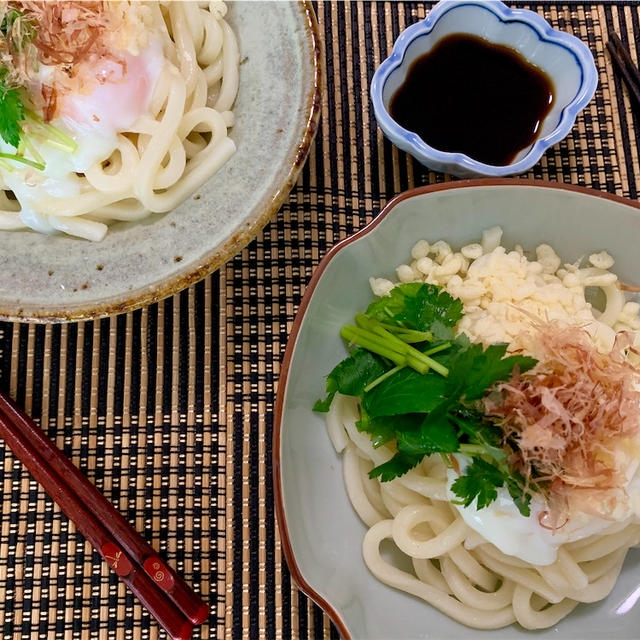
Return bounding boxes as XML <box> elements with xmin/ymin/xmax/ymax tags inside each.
<box><xmin>485</xmin><ymin>321</ymin><xmax>640</xmax><ymax>510</ymax></box>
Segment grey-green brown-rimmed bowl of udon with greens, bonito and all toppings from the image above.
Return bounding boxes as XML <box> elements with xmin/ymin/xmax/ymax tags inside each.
<box><xmin>273</xmin><ymin>179</ymin><xmax>640</xmax><ymax>639</ymax></box>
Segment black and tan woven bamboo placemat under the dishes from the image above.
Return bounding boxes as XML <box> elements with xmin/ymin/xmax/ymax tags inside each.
<box><xmin>0</xmin><ymin>2</ymin><xmax>640</xmax><ymax>640</ymax></box>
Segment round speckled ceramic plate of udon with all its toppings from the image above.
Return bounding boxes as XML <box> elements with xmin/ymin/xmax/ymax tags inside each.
<box><xmin>0</xmin><ymin>0</ymin><xmax>322</xmax><ymax>321</ymax></box>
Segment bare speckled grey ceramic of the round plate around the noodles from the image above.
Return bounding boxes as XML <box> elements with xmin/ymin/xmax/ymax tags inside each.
<box><xmin>0</xmin><ymin>2</ymin><xmax>322</xmax><ymax>321</ymax></box>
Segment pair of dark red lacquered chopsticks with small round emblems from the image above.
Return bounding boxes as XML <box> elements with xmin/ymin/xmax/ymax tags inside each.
<box><xmin>0</xmin><ymin>393</ymin><xmax>209</xmax><ymax>640</ymax></box>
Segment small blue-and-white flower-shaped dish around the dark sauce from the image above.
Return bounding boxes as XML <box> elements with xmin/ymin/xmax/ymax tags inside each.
<box><xmin>371</xmin><ymin>0</ymin><xmax>598</xmax><ymax>177</ymax></box>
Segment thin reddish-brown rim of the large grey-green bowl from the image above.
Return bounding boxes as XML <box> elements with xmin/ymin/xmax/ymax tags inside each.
<box><xmin>271</xmin><ymin>177</ymin><xmax>640</xmax><ymax>640</ymax></box>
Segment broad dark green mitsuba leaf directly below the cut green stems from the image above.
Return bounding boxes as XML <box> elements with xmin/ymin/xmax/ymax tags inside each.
<box><xmin>362</xmin><ymin>368</ymin><xmax>446</xmax><ymax>418</ymax></box>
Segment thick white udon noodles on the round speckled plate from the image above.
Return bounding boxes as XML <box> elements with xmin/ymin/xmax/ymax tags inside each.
<box><xmin>0</xmin><ymin>1</ymin><xmax>239</xmax><ymax>240</ymax></box>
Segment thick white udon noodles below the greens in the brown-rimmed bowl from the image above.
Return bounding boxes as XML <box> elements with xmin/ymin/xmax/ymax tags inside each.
<box><xmin>328</xmin><ymin>396</ymin><xmax>640</xmax><ymax>629</ymax></box>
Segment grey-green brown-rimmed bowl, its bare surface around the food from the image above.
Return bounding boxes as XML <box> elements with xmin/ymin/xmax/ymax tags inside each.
<box><xmin>273</xmin><ymin>179</ymin><xmax>640</xmax><ymax>640</ymax></box>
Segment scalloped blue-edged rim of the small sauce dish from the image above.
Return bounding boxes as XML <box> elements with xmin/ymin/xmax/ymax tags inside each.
<box><xmin>370</xmin><ymin>0</ymin><xmax>598</xmax><ymax>177</ymax></box>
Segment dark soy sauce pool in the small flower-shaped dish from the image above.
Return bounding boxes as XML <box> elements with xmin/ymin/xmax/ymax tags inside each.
<box><xmin>389</xmin><ymin>33</ymin><xmax>554</xmax><ymax>166</ymax></box>
